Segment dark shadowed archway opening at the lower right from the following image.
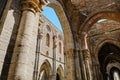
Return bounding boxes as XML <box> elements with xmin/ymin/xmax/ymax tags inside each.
<box><xmin>98</xmin><ymin>42</ymin><xmax>120</xmax><ymax>80</ymax></box>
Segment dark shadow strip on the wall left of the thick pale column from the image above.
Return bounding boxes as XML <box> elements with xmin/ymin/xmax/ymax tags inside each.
<box><xmin>0</xmin><ymin>0</ymin><xmax>21</xmax><ymax>80</ymax></box>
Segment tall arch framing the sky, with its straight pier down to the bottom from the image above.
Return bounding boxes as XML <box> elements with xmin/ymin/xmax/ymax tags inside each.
<box><xmin>42</xmin><ymin>0</ymin><xmax>74</xmax><ymax>80</ymax></box>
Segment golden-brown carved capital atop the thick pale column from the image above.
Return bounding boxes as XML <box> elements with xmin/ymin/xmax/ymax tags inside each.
<box><xmin>21</xmin><ymin>0</ymin><xmax>42</xmax><ymax>13</ymax></box>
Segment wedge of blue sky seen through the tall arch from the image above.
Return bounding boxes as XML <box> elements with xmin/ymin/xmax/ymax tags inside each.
<box><xmin>42</xmin><ymin>6</ymin><xmax>62</xmax><ymax>31</ymax></box>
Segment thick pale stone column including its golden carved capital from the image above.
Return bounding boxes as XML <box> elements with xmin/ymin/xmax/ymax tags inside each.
<box><xmin>9</xmin><ymin>0</ymin><xmax>41</xmax><ymax>80</ymax></box>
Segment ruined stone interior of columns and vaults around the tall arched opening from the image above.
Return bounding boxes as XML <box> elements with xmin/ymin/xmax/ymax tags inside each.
<box><xmin>0</xmin><ymin>0</ymin><xmax>120</xmax><ymax>80</ymax></box>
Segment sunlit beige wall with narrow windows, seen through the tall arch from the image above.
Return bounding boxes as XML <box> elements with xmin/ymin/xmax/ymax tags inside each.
<box><xmin>39</xmin><ymin>15</ymin><xmax>65</xmax><ymax>79</ymax></box>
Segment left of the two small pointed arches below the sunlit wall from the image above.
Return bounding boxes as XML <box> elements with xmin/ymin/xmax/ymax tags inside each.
<box><xmin>38</xmin><ymin>60</ymin><xmax>52</xmax><ymax>80</ymax></box>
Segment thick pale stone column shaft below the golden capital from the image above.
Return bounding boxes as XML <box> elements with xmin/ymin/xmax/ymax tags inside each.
<box><xmin>14</xmin><ymin>11</ymin><xmax>35</xmax><ymax>80</ymax></box>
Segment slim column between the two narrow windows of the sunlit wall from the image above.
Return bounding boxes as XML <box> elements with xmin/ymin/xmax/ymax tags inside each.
<box><xmin>52</xmin><ymin>35</ymin><xmax>57</xmax><ymax>80</ymax></box>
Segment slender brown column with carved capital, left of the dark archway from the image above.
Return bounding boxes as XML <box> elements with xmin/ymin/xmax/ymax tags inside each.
<box><xmin>81</xmin><ymin>33</ymin><xmax>93</xmax><ymax>80</ymax></box>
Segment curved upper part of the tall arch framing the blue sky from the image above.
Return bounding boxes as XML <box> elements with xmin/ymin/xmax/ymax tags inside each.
<box><xmin>47</xmin><ymin>0</ymin><xmax>74</xmax><ymax>51</ymax></box>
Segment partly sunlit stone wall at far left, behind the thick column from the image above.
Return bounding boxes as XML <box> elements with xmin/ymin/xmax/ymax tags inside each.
<box><xmin>0</xmin><ymin>0</ymin><xmax>21</xmax><ymax>80</ymax></box>
